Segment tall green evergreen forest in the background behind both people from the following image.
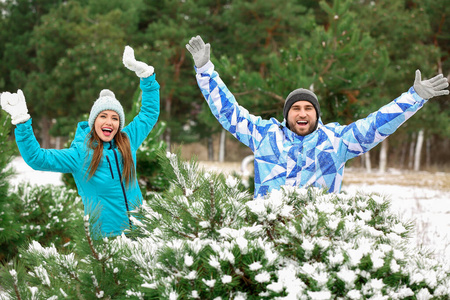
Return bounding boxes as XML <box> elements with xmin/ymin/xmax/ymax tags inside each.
<box><xmin>0</xmin><ymin>0</ymin><xmax>450</xmax><ymax>168</ymax></box>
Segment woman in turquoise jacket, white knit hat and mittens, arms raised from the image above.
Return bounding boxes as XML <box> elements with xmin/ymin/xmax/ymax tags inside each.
<box><xmin>1</xmin><ymin>46</ymin><xmax>159</xmax><ymax>237</ymax></box>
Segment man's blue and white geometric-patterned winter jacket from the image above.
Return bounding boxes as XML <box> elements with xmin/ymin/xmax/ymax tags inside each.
<box><xmin>196</xmin><ymin>61</ymin><xmax>426</xmax><ymax>197</ymax></box>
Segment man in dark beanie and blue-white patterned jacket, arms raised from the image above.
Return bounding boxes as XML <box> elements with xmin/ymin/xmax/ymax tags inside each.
<box><xmin>186</xmin><ymin>36</ymin><xmax>449</xmax><ymax>197</ymax></box>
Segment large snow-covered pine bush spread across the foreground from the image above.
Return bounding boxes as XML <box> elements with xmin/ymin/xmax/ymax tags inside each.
<box><xmin>1</xmin><ymin>153</ymin><xmax>450</xmax><ymax>299</ymax></box>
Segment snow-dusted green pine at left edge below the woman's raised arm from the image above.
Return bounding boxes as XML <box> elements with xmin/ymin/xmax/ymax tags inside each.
<box><xmin>0</xmin><ymin>114</ymin><xmax>83</xmax><ymax>263</ymax></box>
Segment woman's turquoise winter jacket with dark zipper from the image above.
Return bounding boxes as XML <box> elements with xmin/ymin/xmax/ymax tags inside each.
<box><xmin>15</xmin><ymin>74</ymin><xmax>160</xmax><ymax>237</ymax></box>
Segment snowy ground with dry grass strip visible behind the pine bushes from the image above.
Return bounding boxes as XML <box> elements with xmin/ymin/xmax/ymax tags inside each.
<box><xmin>7</xmin><ymin>157</ymin><xmax>450</xmax><ymax>260</ymax></box>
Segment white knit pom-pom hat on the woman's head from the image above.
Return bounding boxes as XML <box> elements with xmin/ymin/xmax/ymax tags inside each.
<box><xmin>89</xmin><ymin>89</ymin><xmax>125</xmax><ymax>130</ymax></box>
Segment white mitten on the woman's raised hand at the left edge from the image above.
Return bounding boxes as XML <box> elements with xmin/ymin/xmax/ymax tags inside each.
<box><xmin>1</xmin><ymin>89</ymin><xmax>30</xmax><ymax>125</ymax></box>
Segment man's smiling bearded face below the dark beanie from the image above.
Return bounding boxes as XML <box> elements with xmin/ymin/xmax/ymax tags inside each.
<box><xmin>287</xmin><ymin>100</ymin><xmax>317</xmax><ymax>136</ymax></box>
